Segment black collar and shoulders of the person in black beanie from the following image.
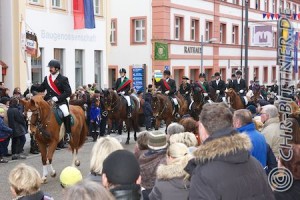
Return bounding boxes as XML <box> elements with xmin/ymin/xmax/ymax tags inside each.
<box><xmin>110</xmin><ymin>184</ymin><xmax>141</xmax><ymax>200</ymax></box>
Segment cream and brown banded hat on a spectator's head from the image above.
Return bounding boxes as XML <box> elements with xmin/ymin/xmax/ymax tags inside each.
<box><xmin>148</xmin><ymin>131</ymin><xmax>168</xmax><ymax>150</ymax></box>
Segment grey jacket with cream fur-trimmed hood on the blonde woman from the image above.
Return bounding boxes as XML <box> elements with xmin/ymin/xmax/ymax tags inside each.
<box><xmin>149</xmin><ymin>156</ymin><xmax>191</xmax><ymax>200</ymax></box>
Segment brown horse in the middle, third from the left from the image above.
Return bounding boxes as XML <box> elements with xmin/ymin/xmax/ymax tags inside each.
<box><xmin>151</xmin><ymin>92</ymin><xmax>188</xmax><ymax>131</ymax></box>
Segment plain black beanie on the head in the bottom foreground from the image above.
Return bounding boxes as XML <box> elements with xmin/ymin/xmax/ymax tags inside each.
<box><xmin>102</xmin><ymin>150</ymin><xmax>140</xmax><ymax>185</ymax></box>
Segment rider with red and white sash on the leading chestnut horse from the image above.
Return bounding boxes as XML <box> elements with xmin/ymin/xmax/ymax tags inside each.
<box><xmin>32</xmin><ymin>59</ymin><xmax>72</xmax><ymax>142</ymax></box>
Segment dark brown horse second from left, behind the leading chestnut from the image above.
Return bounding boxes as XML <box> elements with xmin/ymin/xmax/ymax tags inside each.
<box><xmin>103</xmin><ymin>89</ymin><xmax>140</xmax><ymax>144</ymax></box>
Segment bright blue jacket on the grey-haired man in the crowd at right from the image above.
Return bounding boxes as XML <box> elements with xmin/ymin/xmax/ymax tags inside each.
<box><xmin>237</xmin><ymin>123</ymin><xmax>267</xmax><ymax>167</ymax></box>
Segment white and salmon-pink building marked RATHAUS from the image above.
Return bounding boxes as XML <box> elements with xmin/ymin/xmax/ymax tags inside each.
<box><xmin>108</xmin><ymin>0</ymin><xmax>300</xmax><ymax>88</ymax></box>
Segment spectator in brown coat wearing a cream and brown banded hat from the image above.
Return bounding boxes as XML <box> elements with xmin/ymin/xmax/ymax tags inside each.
<box><xmin>139</xmin><ymin>131</ymin><xmax>167</xmax><ymax>199</ymax></box>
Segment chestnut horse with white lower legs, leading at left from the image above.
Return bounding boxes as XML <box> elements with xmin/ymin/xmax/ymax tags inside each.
<box><xmin>20</xmin><ymin>94</ymin><xmax>88</xmax><ymax>183</ymax></box>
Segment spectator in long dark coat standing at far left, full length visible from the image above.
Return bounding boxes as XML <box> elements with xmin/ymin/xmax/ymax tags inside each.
<box><xmin>7</xmin><ymin>98</ymin><xmax>27</xmax><ymax>160</ymax></box>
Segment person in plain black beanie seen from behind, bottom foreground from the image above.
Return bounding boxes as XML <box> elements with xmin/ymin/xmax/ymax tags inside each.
<box><xmin>102</xmin><ymin>150</ymin><xmax>141</xmax><ymax>200</ymax></box>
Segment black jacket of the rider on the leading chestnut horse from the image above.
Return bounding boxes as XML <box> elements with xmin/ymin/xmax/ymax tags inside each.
<box><xmin>31</xmin><ymin>74</ymin><xmax>72</xmax><ymax>105</ymax></box>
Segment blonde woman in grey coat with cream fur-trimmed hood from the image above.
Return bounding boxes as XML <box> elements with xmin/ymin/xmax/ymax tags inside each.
<box><xmin>149</xmin><ymin>143</ymin><xmax>192</xmax><ymax>200</ymax></box>
